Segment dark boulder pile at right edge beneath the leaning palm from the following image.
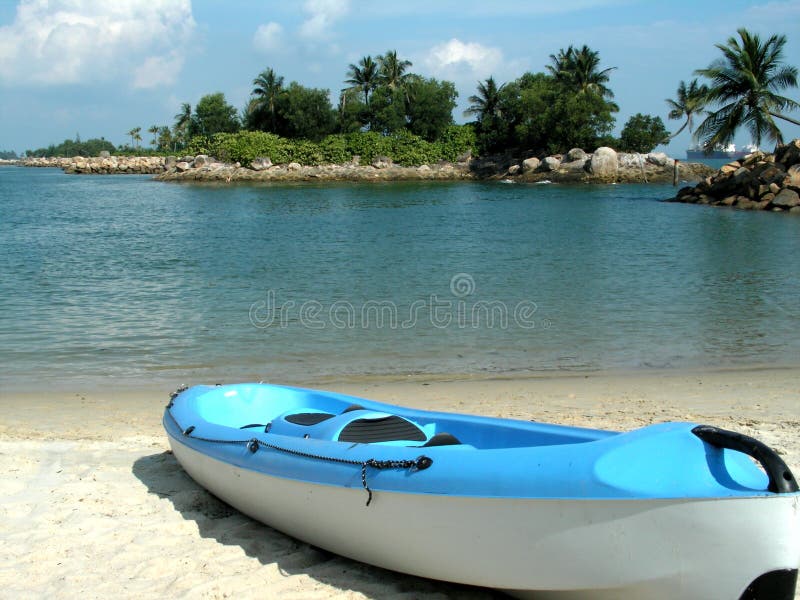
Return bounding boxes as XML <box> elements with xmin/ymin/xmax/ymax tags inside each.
<box><xmin>671</xmin><ymin>139</ymin><xmax>800</xmax><ymax>213</ymax></box>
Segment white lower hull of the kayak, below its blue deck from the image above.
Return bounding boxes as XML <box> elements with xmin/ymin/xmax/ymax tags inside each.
<box><xmin>164</xmin><ymin>384</ymin><xmax>800</xmax><ymax>600</ymax></box>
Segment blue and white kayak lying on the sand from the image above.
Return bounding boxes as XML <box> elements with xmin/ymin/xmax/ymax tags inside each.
<box><xmin>163</xmin><ymin>383</ymin><xmax>800</xmax><ymax>600</ymax></box>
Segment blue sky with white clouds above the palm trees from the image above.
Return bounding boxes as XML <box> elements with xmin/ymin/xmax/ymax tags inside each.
<box><xmin>0</xmin><ymin>0</ymin><xmax>800</xmax><ymax>158</ymax></box>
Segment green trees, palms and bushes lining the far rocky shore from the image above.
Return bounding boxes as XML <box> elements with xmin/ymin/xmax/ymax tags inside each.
<box><xmin>28</xmin><ymin>29</ymin><xmax>800</xmax><ymax>165</ymax></box>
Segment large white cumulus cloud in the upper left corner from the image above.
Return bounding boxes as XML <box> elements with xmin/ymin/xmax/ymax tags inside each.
<box><xmin>0</xmin><ymin>0</ymin><xmax>195</xmax><ymax>88</ymax></box>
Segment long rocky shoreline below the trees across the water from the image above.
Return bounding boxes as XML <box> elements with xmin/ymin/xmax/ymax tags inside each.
<box><xmin>12</xmin><ymin>148</ymin><xmax>714</xmax><ymax>184</ymax></box>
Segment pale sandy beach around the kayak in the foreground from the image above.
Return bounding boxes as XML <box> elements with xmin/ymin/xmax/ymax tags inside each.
<box><xmin>0</xmin><ymin>368</ymin><xmax>800</xmax><ymax>599</ymax></box>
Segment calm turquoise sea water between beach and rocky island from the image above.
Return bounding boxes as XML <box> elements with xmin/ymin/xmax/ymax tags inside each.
<box><xmin>0</xmin><ymin>167</ymin><xmax>800</xmax><ymax>389</ymax></box>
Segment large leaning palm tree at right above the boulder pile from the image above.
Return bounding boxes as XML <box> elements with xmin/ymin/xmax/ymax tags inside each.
<box><xmin>695</xmin><ymin>28</ymin><xmax>800</xmax><ymax>149</ymax></box>
